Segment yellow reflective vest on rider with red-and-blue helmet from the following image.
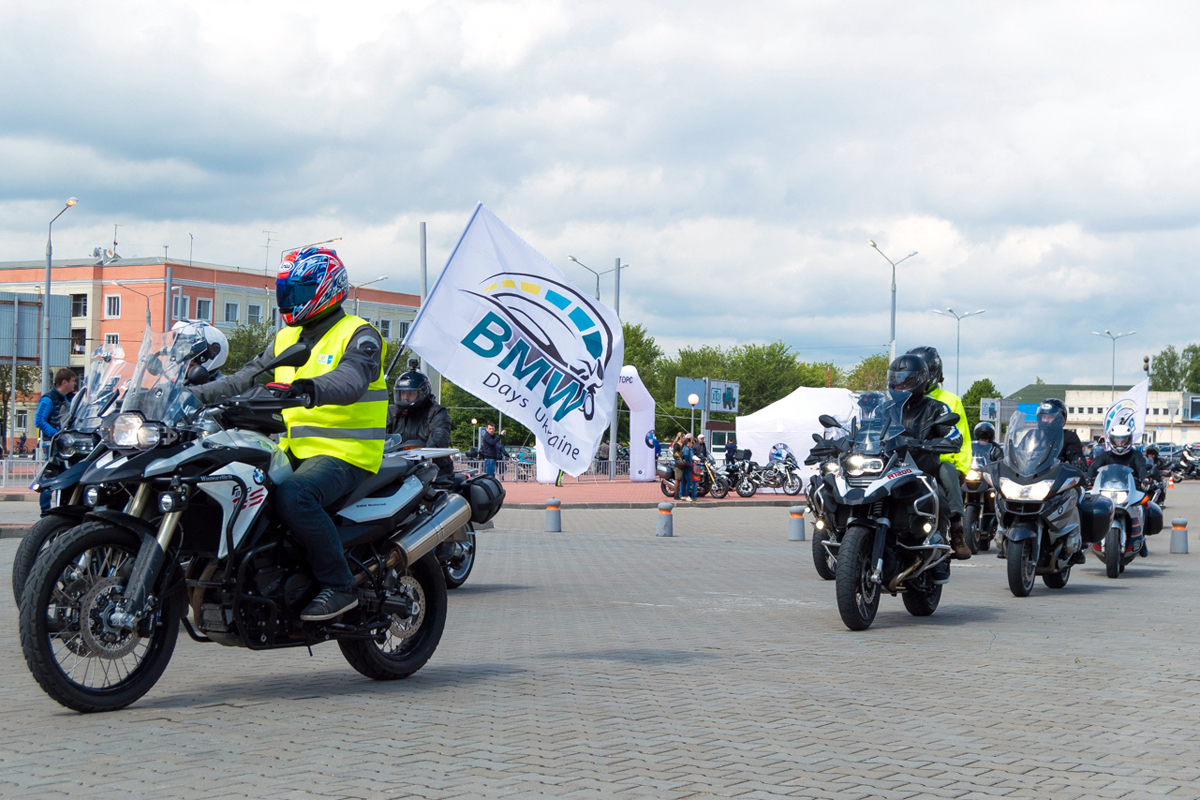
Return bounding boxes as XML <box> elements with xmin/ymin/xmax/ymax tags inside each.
<box><xmin>275</xmin><ymin>314</ymin><xmax>388</xmax><ymax>473</ymax></box>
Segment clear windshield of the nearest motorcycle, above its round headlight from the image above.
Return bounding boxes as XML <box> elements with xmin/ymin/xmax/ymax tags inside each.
<box><xmin>121</xmin><ymin>329</ymin><xmax>208</xmax><ymax>426</ymax></box>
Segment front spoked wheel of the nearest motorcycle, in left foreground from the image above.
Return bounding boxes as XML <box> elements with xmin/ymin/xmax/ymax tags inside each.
<box><xmin>20</xmin><ymin>523</ymin><xmax>184</xmax><ymax>712</ymax></box>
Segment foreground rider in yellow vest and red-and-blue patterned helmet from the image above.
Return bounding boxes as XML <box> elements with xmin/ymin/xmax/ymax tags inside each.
<box><xmin>193</xmin><ymin>246</ymin><xmax>388</xmax><ymax>621</ymax></box>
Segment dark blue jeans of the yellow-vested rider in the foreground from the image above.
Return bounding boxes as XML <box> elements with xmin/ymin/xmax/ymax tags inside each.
<box><xmin>275</xmin><ymin>456</ymin><xmax>371</xmax><ymax>591</ymax></box>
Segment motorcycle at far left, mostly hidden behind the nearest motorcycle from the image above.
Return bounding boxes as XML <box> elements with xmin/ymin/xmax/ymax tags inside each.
<box><xmin>12</xmin><ymin>344</ymin><xmax>133</xmax><ymax>606</ymax></box>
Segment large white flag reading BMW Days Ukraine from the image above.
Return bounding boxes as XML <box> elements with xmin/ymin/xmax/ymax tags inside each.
<box><xmin>404</xmin><ymin>203</ymin><xmax>625</xmax><ymax>476</ymax></box>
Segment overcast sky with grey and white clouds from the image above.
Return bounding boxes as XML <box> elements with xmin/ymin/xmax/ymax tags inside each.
<box><xmin>0</xmin><ymin>0</ymin><xmax>1200</xmax><ymax>393</ymax></box>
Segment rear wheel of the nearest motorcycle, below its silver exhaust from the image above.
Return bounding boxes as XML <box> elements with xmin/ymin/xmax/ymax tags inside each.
<box><xmin>337</xmin><ymin>553</ymin><xmax>446</xmax><ymax>680</ymax></box>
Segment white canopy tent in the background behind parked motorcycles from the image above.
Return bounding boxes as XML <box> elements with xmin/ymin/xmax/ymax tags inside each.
<box><xmin>737</xmin><ymin>386</ymin><xmax>858</xmax><ymax>482</ymax></box>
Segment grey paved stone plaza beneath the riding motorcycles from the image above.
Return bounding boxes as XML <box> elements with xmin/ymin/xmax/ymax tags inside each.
<box><xmin>0</xmin><ymin>485</ymin><xmax>1200</xmax><ymax>800</ymax></box>
